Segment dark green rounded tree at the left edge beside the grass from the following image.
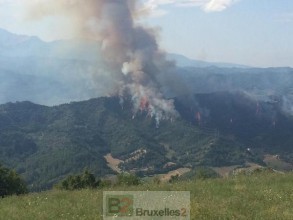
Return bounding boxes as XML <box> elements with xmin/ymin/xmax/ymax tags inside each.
<box><xmin>0</xmin><ymin>164</ymin><xmax>28</xmax><ymax>197</ymax></box>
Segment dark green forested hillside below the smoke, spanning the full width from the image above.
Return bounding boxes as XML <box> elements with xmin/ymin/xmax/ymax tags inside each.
<box><xmin>0</xmin><ymin>93</ymin><xmax>293</xmax><ymax>190</ymax></box>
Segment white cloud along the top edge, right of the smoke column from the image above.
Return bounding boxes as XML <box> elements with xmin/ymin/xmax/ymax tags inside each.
<box><xmin>144</xmin><ymin>0</ymin><xmax>240</xmax><ymax>16</ymax></box>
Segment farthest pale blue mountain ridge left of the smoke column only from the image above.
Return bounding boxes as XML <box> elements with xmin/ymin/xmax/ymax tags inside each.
<box><xmin>0</xmin><ymin>28</ymin><xmax>99</xmax><ymax>61</ymax></box>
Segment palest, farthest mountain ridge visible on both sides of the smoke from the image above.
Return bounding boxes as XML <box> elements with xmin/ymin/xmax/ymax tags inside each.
<box><xmin>0</xmin><ymin>28</ymin><xmax>249</xmax><ymax>68</ymax></box>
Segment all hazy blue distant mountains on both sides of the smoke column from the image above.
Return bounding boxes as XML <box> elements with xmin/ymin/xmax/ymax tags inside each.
<box><xmin>0</xmin><ymin>29</ymin><xmax>293</xmax><ymax>105</ymax></box>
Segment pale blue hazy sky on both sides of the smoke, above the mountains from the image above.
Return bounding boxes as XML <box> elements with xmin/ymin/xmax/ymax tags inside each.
<box><xmin>0</xmin><ymin>0</ymin><xmax>293</xmax><ymax>67</ymax></box>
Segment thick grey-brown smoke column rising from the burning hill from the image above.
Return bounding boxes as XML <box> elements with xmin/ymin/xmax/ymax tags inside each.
<box><xmin>29</xmin><ymin>0</ymin><xmax>177</xmax><ymax>122</ymax></box>
